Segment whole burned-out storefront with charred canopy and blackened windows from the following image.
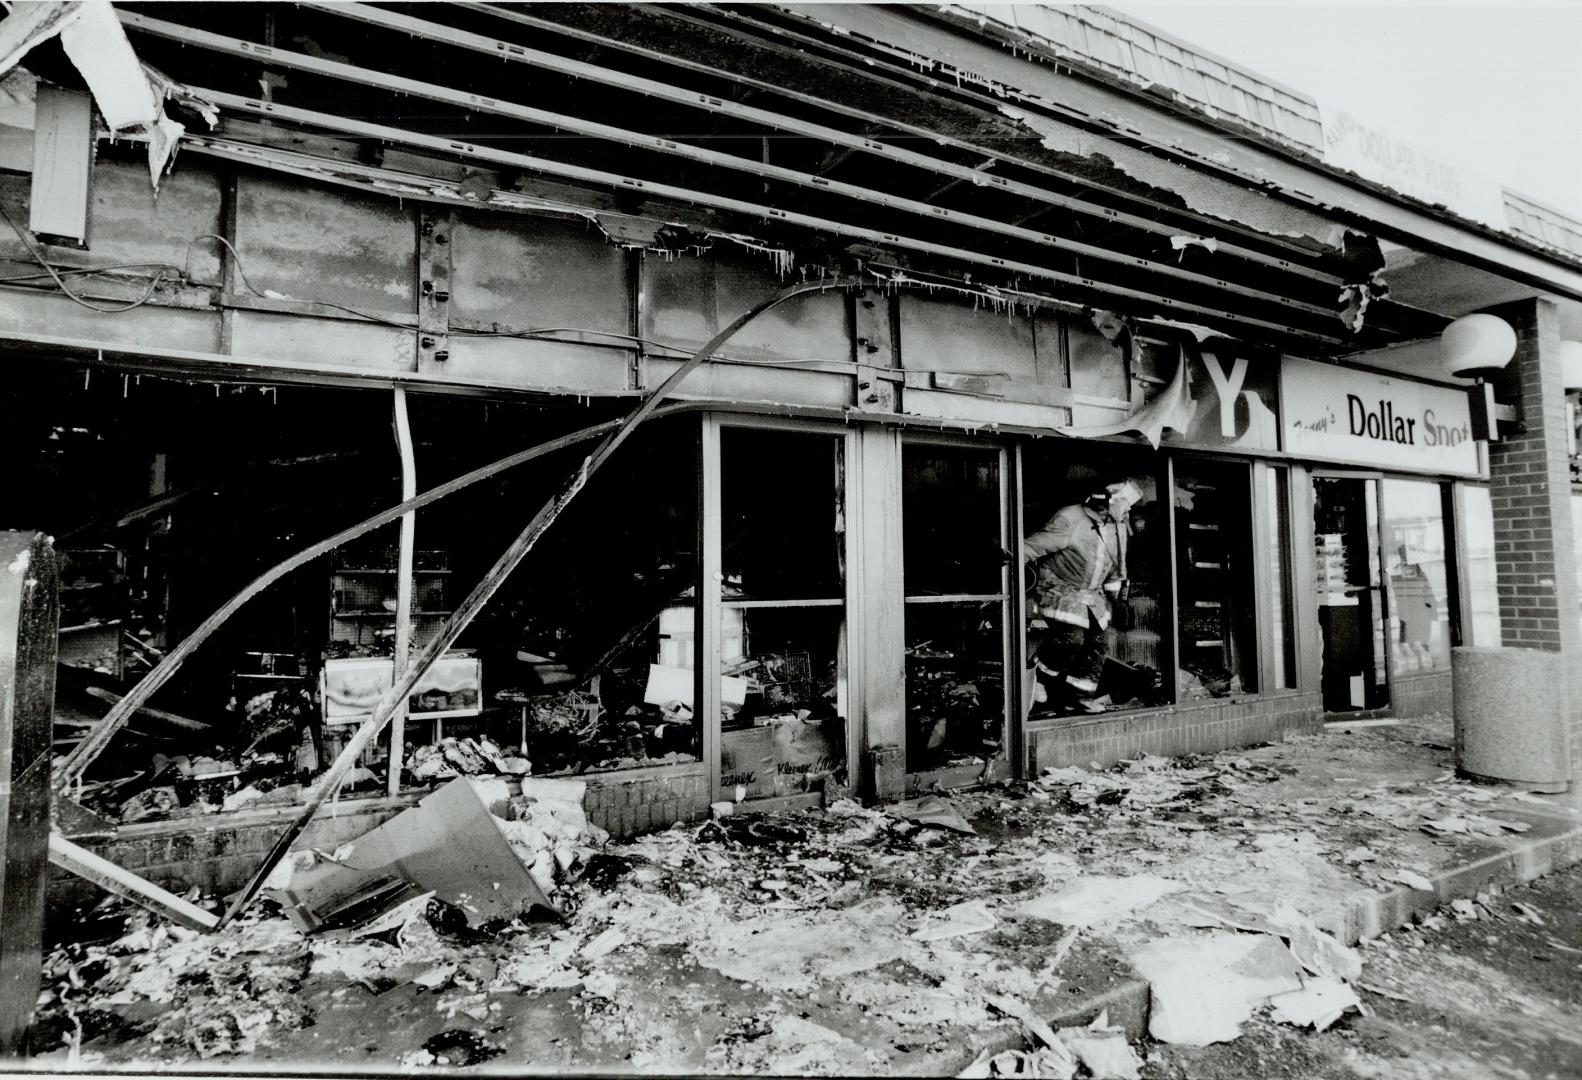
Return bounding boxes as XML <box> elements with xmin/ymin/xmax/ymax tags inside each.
<box><xmin>0</xmin><ymin>3</ymin><xmax>1582</xmax><ymax>929</ymax></box>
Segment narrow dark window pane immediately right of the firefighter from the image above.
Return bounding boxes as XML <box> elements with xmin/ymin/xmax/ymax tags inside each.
<box><xmin>1175</xmin><ymin>460</ymin><xmax>1258</xmax><ymax>700</ymax></box>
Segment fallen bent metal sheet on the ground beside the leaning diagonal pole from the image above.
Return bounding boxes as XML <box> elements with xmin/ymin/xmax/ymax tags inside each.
<box><xmin>274</xmin><ymin>776</ymin><xmax>560</xmax><ymax>930</ymax></box>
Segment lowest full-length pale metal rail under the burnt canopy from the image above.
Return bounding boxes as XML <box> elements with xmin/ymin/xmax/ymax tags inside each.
<box><xmin>180</xmin><ymin>85</ymin><xmax>1351</xmax><ymax>348</ymax></box>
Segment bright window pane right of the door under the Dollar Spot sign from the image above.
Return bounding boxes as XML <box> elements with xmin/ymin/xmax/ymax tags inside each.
<box><xmin>1381</xmin><ymin>479</ymin><xmax>1451</xmax><ymax>675</ymax></box>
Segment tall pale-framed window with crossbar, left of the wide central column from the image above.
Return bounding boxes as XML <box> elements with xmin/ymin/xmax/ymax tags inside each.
<box><xmin>720</xmin><ymin>427</ymin><xmax>848</xmax><ymax>799</ymax></box>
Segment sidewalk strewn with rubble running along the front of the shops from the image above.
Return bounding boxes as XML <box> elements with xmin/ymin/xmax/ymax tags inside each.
<box><xmin>27</xmin><ymin>719</ymin><xmax>1582</xmax><ymax>1075</ymax></box>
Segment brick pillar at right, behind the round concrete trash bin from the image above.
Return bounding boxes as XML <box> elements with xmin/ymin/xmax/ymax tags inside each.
<box><xmin>1489</xmin><ymin>299</ymin><xmax>1582</xmax><ymax>778</ymax></box>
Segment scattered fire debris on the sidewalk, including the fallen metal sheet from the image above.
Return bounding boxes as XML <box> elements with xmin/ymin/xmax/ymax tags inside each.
<box><xmin>30</xmin><ymin>708</ymin><xmax>1563</xmax><ymax>1078</ymax></box>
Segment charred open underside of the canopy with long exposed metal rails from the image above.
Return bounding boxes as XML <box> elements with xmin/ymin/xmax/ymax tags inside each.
<box><xmin>12</xmin><ymin>3</ymin><xmax>1582</xmax><ymax>363</ymax></box>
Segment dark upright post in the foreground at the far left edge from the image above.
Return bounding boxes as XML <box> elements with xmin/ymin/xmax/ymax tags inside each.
<box><xmin>0</xmin><ymin>533</ymin><xmax>60</xmax><ymax>1059</ymax></box>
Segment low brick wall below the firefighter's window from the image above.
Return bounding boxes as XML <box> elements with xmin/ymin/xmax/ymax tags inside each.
<box><xmin>1027</xmin><ymin>694</ymin><xmax>1324</xmax><ymax>776</ymax></box>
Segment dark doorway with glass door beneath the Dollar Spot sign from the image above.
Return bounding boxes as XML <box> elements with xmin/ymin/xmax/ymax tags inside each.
<box><xmin>1313</xmin><ymin>474</ymin><xmax>1389</xmax><ymax>712</ymax></box>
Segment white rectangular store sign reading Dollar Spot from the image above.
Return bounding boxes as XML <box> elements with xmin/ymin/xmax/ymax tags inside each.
<box><xmin>1280</xmin><ymin>357</ymin><xmax>1479</xmax><ymax>476</ymax></box>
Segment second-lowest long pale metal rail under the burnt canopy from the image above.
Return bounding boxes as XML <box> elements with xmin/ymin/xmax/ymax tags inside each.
<box><xmin>122</xmin><ymin>13</ymin><xmax>1338</xmax><ymax>319</ymax></box>
